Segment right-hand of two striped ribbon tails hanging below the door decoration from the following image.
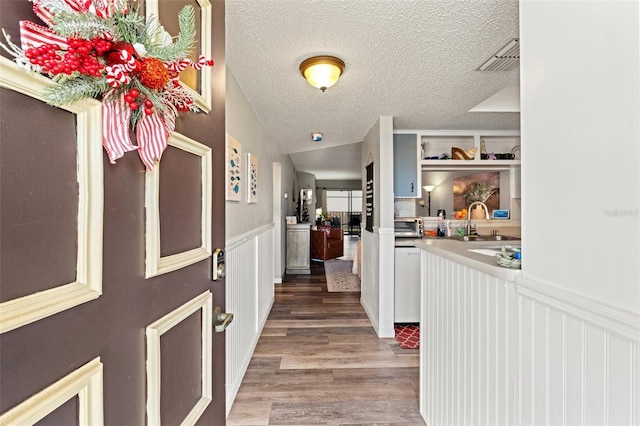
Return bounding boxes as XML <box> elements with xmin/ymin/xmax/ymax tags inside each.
<box><xmin>136</xmin><ymin>112</ymin><xmax>176</xmax><ymax>171</ymax></box>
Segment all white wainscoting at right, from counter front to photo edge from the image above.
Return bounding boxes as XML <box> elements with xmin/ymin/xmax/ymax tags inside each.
<box><xmin>420</xmin><ymin>246</ymin><xmax>640</xmax><ymax>426</ymax></box>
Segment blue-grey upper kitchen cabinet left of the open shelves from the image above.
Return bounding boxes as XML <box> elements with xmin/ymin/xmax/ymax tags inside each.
<box><xmin>393</xmin><ymin>133</ymin><xmax>422</xmax><ymax>198</ymax></box>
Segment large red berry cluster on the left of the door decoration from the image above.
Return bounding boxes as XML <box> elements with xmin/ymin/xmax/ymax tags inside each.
<box><xmin>24</xmin><ymin>37</ymin><xmax>112</xmax><ymax>77</ymax></box>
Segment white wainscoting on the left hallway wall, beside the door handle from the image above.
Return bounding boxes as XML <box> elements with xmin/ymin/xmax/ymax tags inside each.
<box><xmin>225</xmin><ymin>224</ymin><xmax>274</xmax><ymax>414</ymax></box>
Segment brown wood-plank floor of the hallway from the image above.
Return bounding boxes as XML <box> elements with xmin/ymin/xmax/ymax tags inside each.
<box><xmin>227</xmin><ymin>243</ymin><xmax>425</xmax><ymax>425</ymax></box>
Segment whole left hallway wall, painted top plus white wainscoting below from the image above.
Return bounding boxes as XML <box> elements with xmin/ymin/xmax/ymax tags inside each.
<box><xmin>225</xmin><ymin>68</ymin><xmax>296</xmax><ymax>413</ymax></box>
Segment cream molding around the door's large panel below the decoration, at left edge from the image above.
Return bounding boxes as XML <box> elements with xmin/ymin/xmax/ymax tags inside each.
<box><xmin>0</xmin><ymin>57</ymin><xmax>104</xmax><ymax>333</ymax></box>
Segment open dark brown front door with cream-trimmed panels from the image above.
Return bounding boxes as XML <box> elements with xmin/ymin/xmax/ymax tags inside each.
<box><xmin>0</xmin><ymin>0</ymin><xmax>225</xmax><ymax>425</ymax></box>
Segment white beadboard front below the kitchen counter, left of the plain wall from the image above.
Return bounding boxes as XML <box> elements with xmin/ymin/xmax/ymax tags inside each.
<box><xmin>420</xmin><ymin>251</ymin><xmax>515</xmax><ymax>425</ymax></box>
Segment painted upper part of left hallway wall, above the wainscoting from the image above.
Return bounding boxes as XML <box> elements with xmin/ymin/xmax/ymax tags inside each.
<box><xmin>226</xmin><ymin>68</ymin><xmax>294</xmax><ymax>239</ymax></box>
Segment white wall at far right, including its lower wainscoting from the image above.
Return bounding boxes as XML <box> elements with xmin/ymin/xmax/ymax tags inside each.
<box><xmin>512</xmin><ymin>1</ymin><xmax>640</xmax><ymax>425</ymax></box>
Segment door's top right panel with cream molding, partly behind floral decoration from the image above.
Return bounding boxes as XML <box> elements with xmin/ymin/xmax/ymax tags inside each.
<box><xmin>145</xmin><ymin>0</ymin><xmax>212</xmax><ymax>113</ymax></box>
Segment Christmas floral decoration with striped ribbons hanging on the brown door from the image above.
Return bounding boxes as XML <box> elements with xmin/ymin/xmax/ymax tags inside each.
<box><xmin>0</xmin><ymin>0</ymin><xmax>213</xmax><ymax>170</ymax></box>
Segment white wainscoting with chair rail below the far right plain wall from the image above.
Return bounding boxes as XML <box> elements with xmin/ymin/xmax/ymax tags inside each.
<box><xmin>517</xmin><ymin>278</ymin><xmax>640</xmax><ymax>426</ymax></box>
